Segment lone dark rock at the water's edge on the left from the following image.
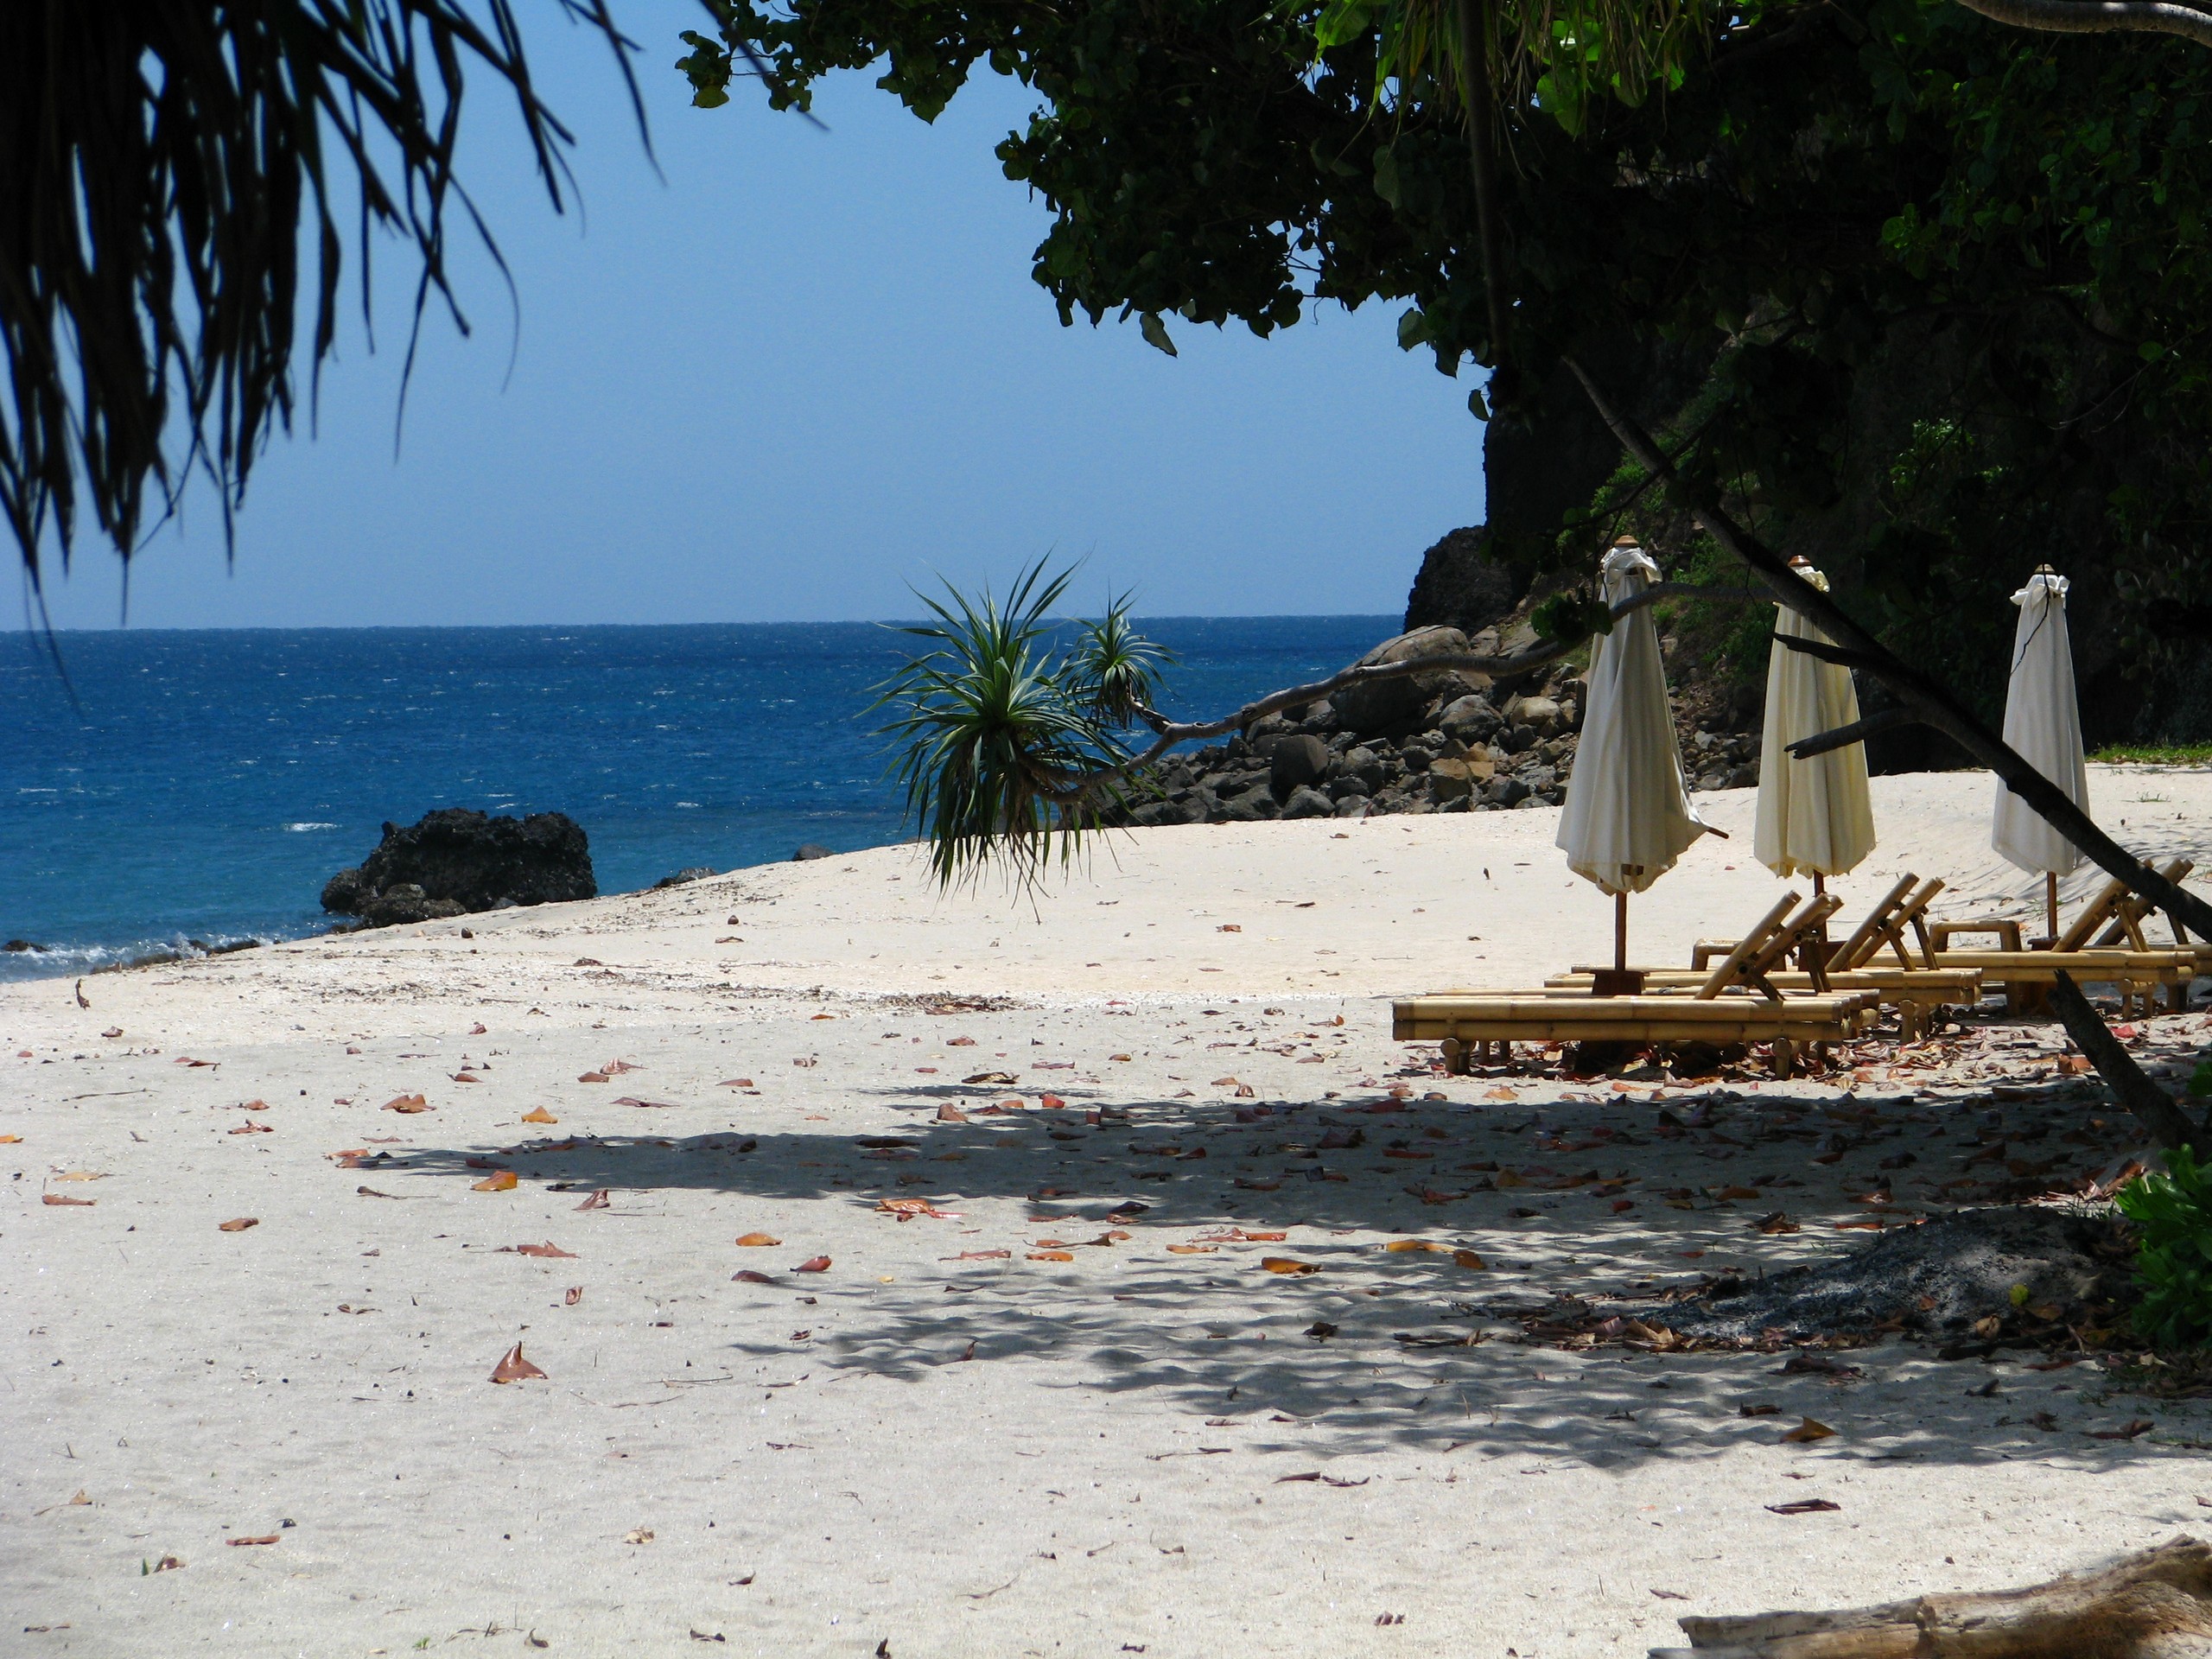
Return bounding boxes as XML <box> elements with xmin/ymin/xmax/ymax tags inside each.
<box><xmin>323</xmin><ymin>807</ymin><xmax>600</xmax><ymax>927</ymax></box>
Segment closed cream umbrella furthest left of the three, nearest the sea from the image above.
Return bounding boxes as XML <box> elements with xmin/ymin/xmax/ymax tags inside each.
<box><xmin>1557</xmin><ymin>536</ymin><xmax>1707</xmax><ymax>971</ymax></box>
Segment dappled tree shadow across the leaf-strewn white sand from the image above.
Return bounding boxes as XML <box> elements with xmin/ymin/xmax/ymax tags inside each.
<box><xmin>387</xmin><ymin>1089</ymin><xmax>2196</xmax><ymax>1478</ymax></box>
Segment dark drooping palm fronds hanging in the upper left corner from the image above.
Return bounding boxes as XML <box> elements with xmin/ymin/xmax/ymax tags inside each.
<box><xmin>0</xmin><ymin>0</ymin><xmax>644</xmax><ymax>588</ymax></box>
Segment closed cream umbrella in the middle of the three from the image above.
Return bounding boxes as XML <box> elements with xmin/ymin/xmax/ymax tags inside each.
<box><xmin>1752</xmin><ymin>560</ymin><xmax>1873</xmax><ymax>889</ymax></box>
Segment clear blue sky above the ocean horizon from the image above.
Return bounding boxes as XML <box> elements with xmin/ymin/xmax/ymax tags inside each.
<box><xmin>21</xmin><ymin>0</ymin><xmax>1482</xmax><ymax>628</ymax></box>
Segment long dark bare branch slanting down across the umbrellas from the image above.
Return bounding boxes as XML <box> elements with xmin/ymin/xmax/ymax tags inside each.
<box><xmin>1561</xmin><ymin>359</ymin><xmax>2212</xmax><ymax>938</ymax></box>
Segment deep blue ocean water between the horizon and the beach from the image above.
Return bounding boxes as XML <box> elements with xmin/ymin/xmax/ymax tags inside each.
<box><xmin>0</xmin><ymin>617</ymin><xmax>1398</xmax><ymax>978</ymax></box>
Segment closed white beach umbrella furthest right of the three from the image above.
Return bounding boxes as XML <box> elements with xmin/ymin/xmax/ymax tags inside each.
<box><xmin>1988</xmin><ymin>564</ymin><xmax>2088</xmax><ymax>938</ymax></box>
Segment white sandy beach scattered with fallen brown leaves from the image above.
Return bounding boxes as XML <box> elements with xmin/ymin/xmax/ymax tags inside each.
<box><xmin>13</xmin><ymin>767</ymin><xmax>2212</xmax><ymax>1659</ymax></box>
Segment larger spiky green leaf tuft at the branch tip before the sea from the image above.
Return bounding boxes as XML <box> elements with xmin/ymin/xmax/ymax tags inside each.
<box><xmin>872</xmin><ymin>560</ymin><xmax>1128</xmax><ymax>887</ymax></box>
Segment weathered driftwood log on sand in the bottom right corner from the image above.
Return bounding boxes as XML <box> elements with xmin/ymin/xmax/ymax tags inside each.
<box><xmin>1652</xmin><ymin>1537</ymin><xmax>2212</xmax><ymax>1659</ymax></box>
